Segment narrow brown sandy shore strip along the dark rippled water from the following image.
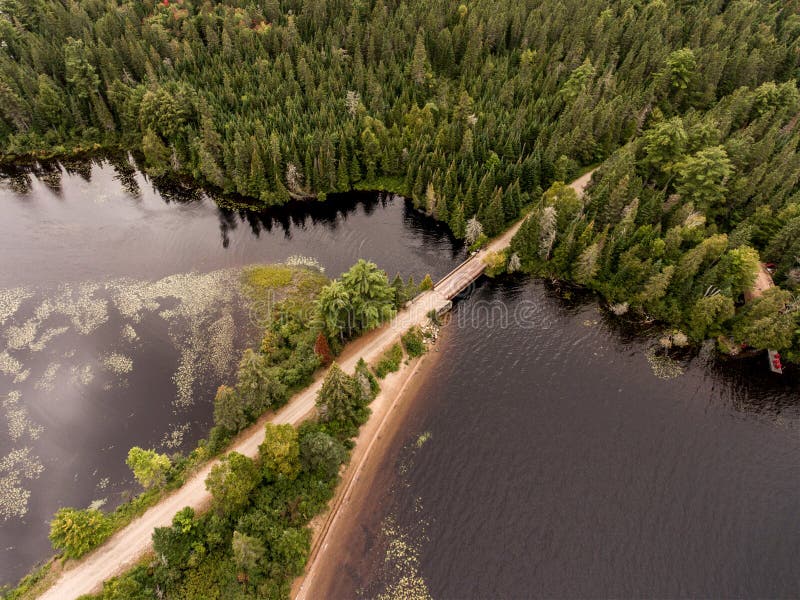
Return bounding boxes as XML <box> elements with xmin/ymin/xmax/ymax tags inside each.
<box><xmin>292</xmin><ymin>324</ymin><xmax>442</xmax><ymax>600</ymax></box>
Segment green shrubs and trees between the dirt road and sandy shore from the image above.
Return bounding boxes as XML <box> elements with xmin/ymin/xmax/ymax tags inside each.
<box><xmin>66</xmin><ymin>282</ymin><xmax>424</xmax><ymax>600</ymax></box>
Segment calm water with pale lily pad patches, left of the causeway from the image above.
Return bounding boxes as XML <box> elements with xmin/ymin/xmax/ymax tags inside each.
<box><xmin>0</xmin><ymin>162</ymin><xmax>462</xmax><ymax>585</ymax></box>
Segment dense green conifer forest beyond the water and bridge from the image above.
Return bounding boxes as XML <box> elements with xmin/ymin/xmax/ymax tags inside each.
<box><xmin>0</xmin><ymin>0</ymin><xmax>800</xmax><ymax>360</ymax></box>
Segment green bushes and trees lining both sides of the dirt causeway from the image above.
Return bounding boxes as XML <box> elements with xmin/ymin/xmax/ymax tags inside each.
<box><xmin>6</xmin><ymin>257</ymin><xmax>428</xmax><ymax>598</ymax></box>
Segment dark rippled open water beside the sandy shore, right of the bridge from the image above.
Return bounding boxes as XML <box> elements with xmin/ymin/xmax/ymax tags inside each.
<box><xmin>331</xmin><ymin>281</ymin><xmax>800</xmax><ymax>599</ymax></box>
